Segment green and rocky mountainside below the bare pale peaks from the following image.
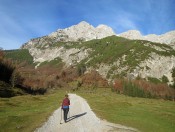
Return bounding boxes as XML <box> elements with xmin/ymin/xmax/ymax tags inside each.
<box><xmin>20</xmin><ymin>36</ymin><xmax>175</xmax><ymax>83</ymax></box>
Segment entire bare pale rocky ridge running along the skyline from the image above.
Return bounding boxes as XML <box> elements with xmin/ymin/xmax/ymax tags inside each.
<box><xmin>21</xmin><ymin>21</ymin><xmax>175</xmax><ymax>49</ymax></box>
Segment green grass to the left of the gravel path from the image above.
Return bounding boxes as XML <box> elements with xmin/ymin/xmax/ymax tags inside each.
<box><xmin>0</xmin><ymin>90</ymin><xmax>65</xmax><ymax>132</ymax></box>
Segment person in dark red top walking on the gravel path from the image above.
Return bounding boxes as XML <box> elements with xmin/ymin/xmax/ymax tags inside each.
<box><xmin>62</xmin><ymin>94</ymin><xmax>70</xmax><ymax>122</ymax></box>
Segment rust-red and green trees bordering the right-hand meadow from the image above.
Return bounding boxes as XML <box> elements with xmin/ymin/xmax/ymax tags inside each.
<box><xmin>113</xmin><ymin>79</ymin><xmax>175</xmax><ymax>100</ymax></box>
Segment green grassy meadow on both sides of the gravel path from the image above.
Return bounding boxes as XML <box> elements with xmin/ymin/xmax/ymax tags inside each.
<box><xmin>0</xmin><ymin>88</ymin><xmax>175</xmax><ymax>132</ymax></box>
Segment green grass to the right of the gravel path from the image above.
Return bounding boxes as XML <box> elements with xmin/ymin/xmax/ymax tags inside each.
<box><xmin>78</xmin><ymin>89</ymin><xmax>175</xmax><ymax>132</ymax></box>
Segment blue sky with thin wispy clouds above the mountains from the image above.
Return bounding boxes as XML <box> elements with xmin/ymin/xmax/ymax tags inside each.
<box><xmin>0</xmin><ymin>0</ymin><xmax>175</xmax><ymax>49</ymax></box>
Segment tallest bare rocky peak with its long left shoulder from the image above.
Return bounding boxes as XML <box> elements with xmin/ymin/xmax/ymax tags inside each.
<box><xmin>22</xmin><ymin>21</ymin><xmax>115</xmax><ymax>48</ymax></box>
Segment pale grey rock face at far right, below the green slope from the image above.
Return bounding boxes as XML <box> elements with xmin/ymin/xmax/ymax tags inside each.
<box><xmin>129</xmin><ymin>53</ymin><xmax>175</xmax><ymax>82</ymax></box>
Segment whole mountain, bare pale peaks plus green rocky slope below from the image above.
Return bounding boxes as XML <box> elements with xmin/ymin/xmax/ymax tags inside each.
<box><xmin>21</xmin><ymin>21</ymin><xmax>175</xmax><ymax>83</ymax></box>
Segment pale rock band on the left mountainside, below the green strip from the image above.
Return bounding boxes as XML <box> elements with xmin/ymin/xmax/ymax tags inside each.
<box><xmin>29</xmin><ymin>47</ymin><xmax>90</xmax><ymax>66</ymax></box>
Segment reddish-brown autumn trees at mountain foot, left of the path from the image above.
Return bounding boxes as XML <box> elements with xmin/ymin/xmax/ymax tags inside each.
<box><xmin>20</xmin><ymin>66</ymin><xmax>77</xmax><ymax>91</ymax></box>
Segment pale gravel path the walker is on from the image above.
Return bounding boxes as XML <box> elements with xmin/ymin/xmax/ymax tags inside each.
<box><xmin>35</xmin><ymin>94</ymin><xmax>137</xmax><ymax>132</ymax></box>
